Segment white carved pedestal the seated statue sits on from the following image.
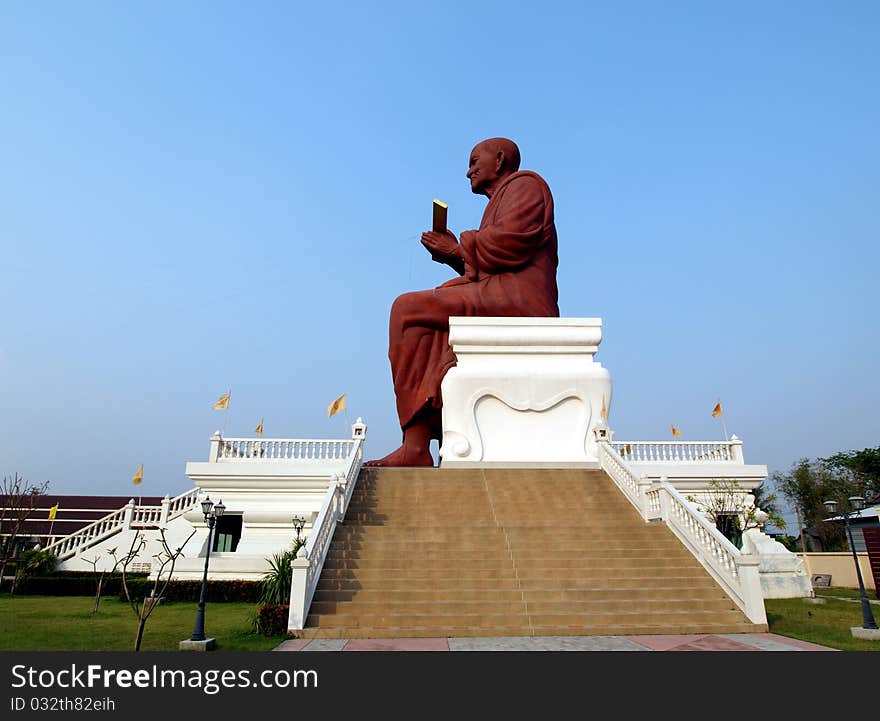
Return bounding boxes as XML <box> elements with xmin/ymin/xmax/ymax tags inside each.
<box><xmin>440</xmin><ymin>317</ymin><xmax>611</xmax><ymax>468</ymax></box>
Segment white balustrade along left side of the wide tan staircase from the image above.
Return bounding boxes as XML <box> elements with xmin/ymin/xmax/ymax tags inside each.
<box><xmin>287</xmin><ymin>437</ymin><xmax>364</xmax><ymax>635</ymax></box>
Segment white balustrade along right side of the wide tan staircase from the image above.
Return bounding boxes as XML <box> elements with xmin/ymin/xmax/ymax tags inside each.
<box><xmin>599</xmin><ymin>441</ymin><xmax>767</xmax><ymax>624</ymax></box>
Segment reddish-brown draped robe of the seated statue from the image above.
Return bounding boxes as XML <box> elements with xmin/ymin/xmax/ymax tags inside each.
<box><xmin>388</xmin><ymin>171</ymin><xmax>559</xmax><ymax>437</ymax></box>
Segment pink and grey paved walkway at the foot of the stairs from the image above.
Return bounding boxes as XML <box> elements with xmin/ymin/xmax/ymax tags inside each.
<box><xmin>273</xmin><ymin>633</ymin><xmax>836</xmax><ymax>651</ymax></box>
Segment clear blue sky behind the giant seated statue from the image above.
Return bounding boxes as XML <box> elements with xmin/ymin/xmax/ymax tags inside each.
<box><xmin>0</xmin><ymin>2</ymin><xmax>880</xmax><ymax>520</ymax></box>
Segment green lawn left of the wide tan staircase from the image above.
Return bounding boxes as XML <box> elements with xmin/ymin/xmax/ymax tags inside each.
<box><xmin>0</xmin><ymin>593</ymin><xmax>284</xmax><ymax>651</ymax></box>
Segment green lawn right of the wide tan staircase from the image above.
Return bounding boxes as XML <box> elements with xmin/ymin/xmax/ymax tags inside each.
<box><xmin>764</xmin><ymin>588</ymin><xmax>880</xmax><ymax>651</ymax></box>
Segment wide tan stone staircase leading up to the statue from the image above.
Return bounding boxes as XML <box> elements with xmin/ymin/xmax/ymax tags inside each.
<box><xmin>304</xmin><ymin>468</ymin><xmax>767</xmax><ymax>638</ymax></box>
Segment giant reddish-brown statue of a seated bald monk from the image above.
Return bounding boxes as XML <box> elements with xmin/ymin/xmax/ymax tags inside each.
<box><xmin>365</xmin><ymin>138</ymin><xmax>559</xmax><ymax>466</ymax></box>
